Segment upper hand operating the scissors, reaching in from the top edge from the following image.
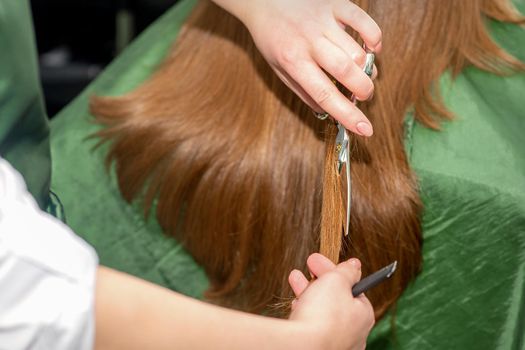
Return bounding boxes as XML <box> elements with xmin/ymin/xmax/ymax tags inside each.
<box><xmin>214</xmin><ymin>0</ymin><xmax>381</xmax><ymax>136</ymax></box>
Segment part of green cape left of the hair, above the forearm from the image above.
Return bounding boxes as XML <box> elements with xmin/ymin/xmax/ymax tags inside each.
<box><xmin>51</xmin><ymin>0</ymin><xmax>207</xmax><ymax>297</ymax></box>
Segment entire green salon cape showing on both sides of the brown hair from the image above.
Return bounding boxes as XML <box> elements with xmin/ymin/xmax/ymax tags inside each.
<box><xmin>51</xmin><ymin>1</ymin><xmax>525</xmax><ymax>350</ymax></box>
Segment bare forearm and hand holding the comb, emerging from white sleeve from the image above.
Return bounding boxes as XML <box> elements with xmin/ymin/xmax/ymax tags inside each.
<box><xmin>95</xmin><ymin>254</ymin><xmax>374</xmax><ymax>350</ymax></box>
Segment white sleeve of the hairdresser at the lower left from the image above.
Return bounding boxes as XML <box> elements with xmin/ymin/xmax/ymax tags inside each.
<box><xmin>0</xmin><ymin>158</ymin><xmax>98</xmax><ymax>350</ymax></box>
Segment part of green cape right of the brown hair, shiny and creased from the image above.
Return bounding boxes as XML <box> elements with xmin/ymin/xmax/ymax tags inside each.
<box><xmin>368</xmin><ymin>9</ymin><xmax>525</xmax><ymax>350</ymax></box>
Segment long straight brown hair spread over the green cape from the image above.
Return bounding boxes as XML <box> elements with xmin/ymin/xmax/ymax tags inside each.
<box><xmin>91</xmin><ymin>0</ymin><xmax>523</xmax><ymax>316</ymax></box>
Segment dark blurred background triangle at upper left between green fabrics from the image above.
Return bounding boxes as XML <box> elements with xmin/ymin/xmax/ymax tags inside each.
<box><xmin>31</xmin><ymin>0</ymin><xmax>177</xmax><ymax>117</ymax></box>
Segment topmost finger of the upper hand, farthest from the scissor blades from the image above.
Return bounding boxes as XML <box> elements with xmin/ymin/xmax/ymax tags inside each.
<box><xmin>334</xmin><ymin>0</ymin><xmax>382</xmax><ymax>52</ymax></box>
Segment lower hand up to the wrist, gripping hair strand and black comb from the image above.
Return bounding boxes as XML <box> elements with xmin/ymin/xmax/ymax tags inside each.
<box><xmin>289</xmin><ymin>254</ymin><xmax>374</xmax><ymax>350</ymax></box>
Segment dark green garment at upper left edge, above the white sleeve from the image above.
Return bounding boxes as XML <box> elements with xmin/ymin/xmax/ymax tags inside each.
<box><xmin>0</xmin><ymin>0</ymin><xmax>51</xmax><ymax>208</ymax></box>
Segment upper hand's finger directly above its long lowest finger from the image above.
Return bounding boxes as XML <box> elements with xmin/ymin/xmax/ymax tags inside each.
<box><xmin>312</xmin><ymin>38</ymin><xmax>374</xmax><ymax>101</ymax></box>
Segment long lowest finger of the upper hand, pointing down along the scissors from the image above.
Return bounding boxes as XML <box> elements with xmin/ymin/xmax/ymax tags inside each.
<box><xmin>288</xmin><ymin>61</ymin><xmax>374</xmax><ymax>136</ymax></box>
